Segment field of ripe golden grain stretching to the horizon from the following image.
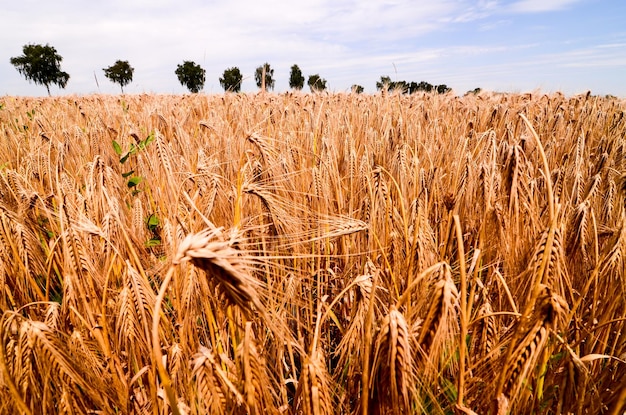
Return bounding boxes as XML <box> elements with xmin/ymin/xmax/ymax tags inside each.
<box><xmin>0</xmin><ymin>92</ymin><xmax>626</xmax><ymax>415</ymax></box>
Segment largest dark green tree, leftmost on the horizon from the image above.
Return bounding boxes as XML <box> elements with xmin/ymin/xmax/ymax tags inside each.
<box><xmin>11</xmin><ymin>44</ymin><xmax>70</xmax><ymax>95</ymax></box>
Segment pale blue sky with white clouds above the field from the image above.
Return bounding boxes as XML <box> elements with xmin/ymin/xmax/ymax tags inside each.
<box><xmin>0</xmin><ymin>0</ymin><xmax>626</xmax><ymax>97</ymax></box>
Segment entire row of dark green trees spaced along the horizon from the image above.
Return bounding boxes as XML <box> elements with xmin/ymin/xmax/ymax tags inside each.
<box><xmin>10</xmin><ymin>44</ymin><xmax>464</xmax><ymax>95</ymax></box>
